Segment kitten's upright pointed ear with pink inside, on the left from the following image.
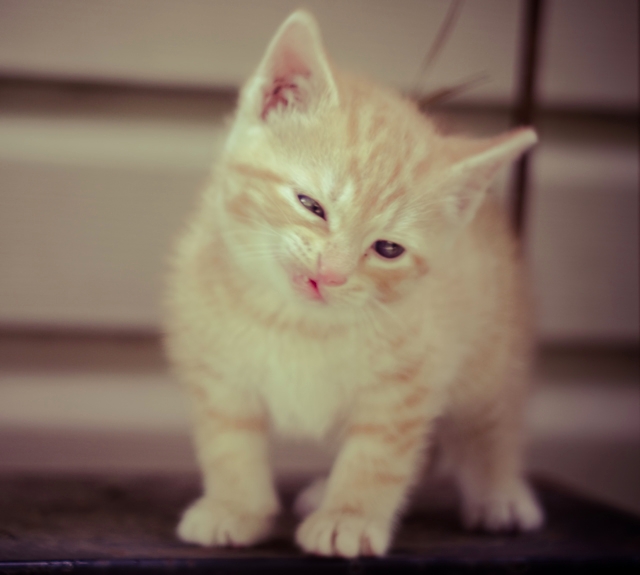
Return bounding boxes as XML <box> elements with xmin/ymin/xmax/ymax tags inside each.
<box><xmin>240</xmin><ymin>10</ymin><xmax>338</xmax><ymax>120</ymax></box>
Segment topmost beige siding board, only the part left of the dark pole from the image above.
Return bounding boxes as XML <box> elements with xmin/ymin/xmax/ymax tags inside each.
<box><xmin>0</xmin><ymin>0</ymin><xmax>520</xmax><ymax>101</ymax></box>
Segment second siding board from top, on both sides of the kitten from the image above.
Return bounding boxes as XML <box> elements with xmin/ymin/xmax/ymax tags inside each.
<box><xmin>0</xmin><ymin>92</ymin><xmax>639</xmax><ymax>341</ymax></box>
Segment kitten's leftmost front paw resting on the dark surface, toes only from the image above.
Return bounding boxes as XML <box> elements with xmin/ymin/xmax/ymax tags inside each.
<box><xmin>177</xmin><ymin>497</ymin><xmax>273</xmax><ymax>547</ymax></box>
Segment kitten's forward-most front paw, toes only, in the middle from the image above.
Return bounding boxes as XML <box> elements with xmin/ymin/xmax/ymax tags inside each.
<box><xmin>296</xmin><ymin>510</ymin><xmax>391</xmax><ymax>557</ymax></box>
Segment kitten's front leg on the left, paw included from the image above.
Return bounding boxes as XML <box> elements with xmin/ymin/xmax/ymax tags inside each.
<box><xmin>177</xmin><ymin>388</ymin><xmax>279</xmax><ymax>546</ymax></box>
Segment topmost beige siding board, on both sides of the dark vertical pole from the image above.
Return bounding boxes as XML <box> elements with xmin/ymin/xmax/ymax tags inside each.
<box><xmin>0</xmin><ymin>0</ymin><xmax>638</xmax><ymax>108</ymax></box>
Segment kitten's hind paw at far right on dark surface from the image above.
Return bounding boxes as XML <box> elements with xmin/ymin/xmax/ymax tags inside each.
<box><xmin>463</xmin><ymin>483</ymin><xmax>544</xmax><ymax>531</ymax></box>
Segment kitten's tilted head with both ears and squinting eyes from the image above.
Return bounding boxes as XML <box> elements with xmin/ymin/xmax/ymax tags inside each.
<box><xmin>215</xmin><ymin>11</ymin><xmax>536</xmax><ymax>311</ymax></box>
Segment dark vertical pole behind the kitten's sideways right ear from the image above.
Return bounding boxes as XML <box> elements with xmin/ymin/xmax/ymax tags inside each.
<box><xmin>511</xmin><ymin>0</ymin><xmax>544</xmax><ymax>236</ymax></box>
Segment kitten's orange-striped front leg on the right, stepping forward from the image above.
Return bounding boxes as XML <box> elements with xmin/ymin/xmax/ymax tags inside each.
<box><xmin>296</xmin><ymin>385</ymin><xmax>432</xmax><ymax>557</ymax></box>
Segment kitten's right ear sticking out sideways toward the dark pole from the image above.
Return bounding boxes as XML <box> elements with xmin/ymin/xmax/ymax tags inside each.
<box><xmin>443</xmin><ymin>128</ymin><xmax>538</xmax><ymax>224</ymax></box>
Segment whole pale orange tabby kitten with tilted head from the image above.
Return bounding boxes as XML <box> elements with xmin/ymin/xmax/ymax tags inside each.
<box><xmin>166</xmin><ymin>11</ymin><xmax>542</xmax><ymax>557</ymax></box>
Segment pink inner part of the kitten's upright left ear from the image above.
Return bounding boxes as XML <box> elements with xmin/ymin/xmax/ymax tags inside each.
<box><xmin>260</xmin><ymin>49</ymin><xmax>311</xmax><ymax>120</ymax></box>
